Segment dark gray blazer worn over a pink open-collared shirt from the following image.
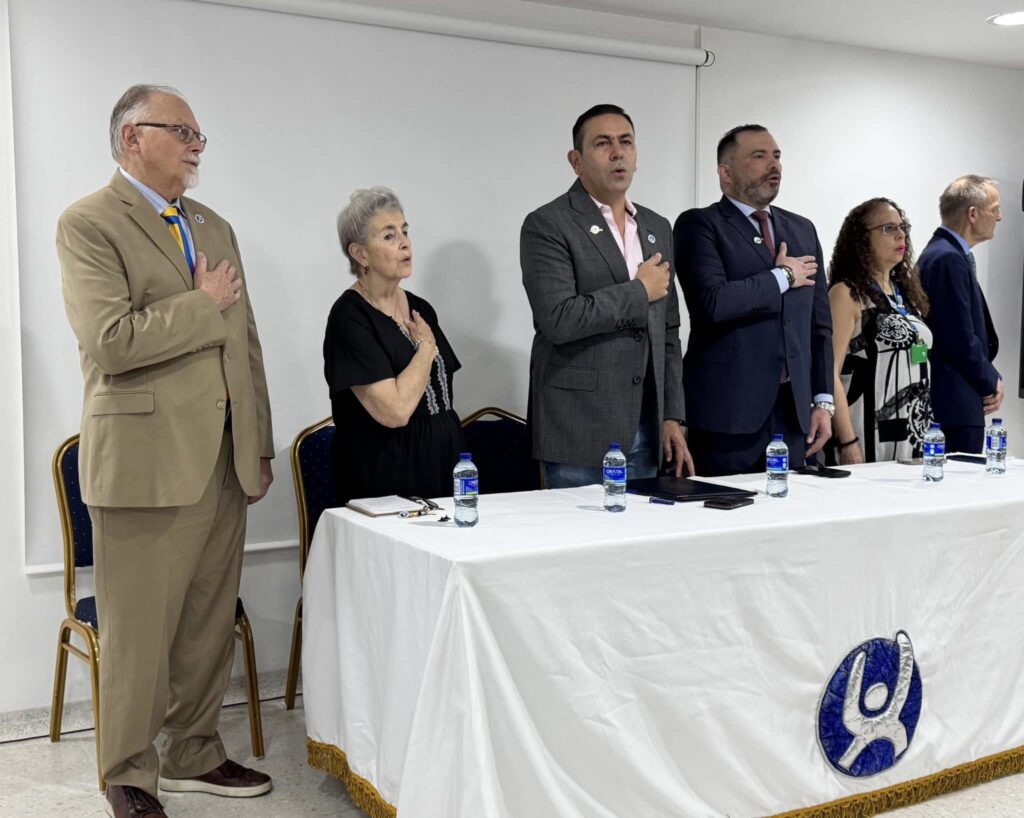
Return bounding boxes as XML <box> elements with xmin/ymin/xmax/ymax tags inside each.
<box><xmin>519</xmin><ymin>180</ymin><xmax>683</xmax><ymax>466</ymax></box>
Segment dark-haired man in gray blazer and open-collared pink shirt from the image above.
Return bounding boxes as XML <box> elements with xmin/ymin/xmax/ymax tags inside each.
<box><xmin>519</xmin><ymin>104</ymin><xmax>693</xmax><ymax>488</ymax></box>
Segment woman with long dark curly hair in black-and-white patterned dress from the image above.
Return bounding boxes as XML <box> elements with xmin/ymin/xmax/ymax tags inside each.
<box><xmin>828</xmin><ymin>198</ymin><xmax>932</xmax><ymax>464</ymax></box>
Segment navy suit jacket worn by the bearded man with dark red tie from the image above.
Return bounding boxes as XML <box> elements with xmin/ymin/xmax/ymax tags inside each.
<box><xmin>674</xmin><ymin>197</ymin><xmax>834</xmax><ymax>434</ymax></box>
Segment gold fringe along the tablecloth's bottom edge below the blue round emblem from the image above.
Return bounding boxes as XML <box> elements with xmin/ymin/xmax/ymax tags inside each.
<box><xmin>772</xmin><ymin>747</ymin><xmax>1024</xmax><ymax>818</ymax></box>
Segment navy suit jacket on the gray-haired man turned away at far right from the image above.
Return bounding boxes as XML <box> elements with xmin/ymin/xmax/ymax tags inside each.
<box><xmin>918</xmin><ymin>227</ymin><xmax>999</xmax><ymax>426</ymax></box>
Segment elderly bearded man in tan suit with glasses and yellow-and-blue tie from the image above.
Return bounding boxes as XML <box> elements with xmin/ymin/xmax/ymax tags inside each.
<box><xmin>57</xmin><ymin>85</ymin><xmax>274</xmax><ymax>818</ymax></box>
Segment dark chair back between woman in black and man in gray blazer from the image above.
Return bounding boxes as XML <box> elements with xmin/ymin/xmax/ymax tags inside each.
<box><xmin>462</xmin><ymin>406</ymin><xmax>544</xmax><ymax>493</ymax></box>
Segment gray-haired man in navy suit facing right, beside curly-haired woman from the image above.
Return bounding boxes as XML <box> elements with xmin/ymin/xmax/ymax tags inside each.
<box><xmin>918</xmin><ymin>176</ymin><xmax>1002</xmax><ymax>453</ymax></box>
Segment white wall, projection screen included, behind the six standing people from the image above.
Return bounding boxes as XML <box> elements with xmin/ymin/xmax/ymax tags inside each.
<box><xmin>0</xmin><ymin>6</ymin><xmax>1024</xmax><ymax>712</ymax></box>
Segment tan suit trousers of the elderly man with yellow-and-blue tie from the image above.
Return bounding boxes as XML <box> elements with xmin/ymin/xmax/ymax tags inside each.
<box><xmin>89</xmin><ymin>428</ymin><xmax>246</xmax><ymax>795</ymax></box>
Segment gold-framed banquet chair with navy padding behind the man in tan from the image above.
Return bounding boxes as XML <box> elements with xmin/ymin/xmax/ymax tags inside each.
<box><xmin>50</xmin><ymin>434</ymin><xmax>263</xmax><ymax>790</ymax></box>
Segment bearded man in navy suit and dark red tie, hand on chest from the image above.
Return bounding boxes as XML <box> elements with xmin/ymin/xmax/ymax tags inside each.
<box><xmin>674</xmin><ymin>125</ymin><xmax>836</xmax><ymax>475</ymax></box>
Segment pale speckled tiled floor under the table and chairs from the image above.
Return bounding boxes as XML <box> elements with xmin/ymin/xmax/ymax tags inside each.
<box><xmin>0</xmin><ymin>697</ymin><xmax>1024</xmax><ymax>818</ymax></box>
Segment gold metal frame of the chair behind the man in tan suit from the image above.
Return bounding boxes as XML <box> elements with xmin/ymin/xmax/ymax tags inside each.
<box><xmin>50</xmin><ymin>434</ymin><xmax>264</xmax><ymax>791</ymax></box>
